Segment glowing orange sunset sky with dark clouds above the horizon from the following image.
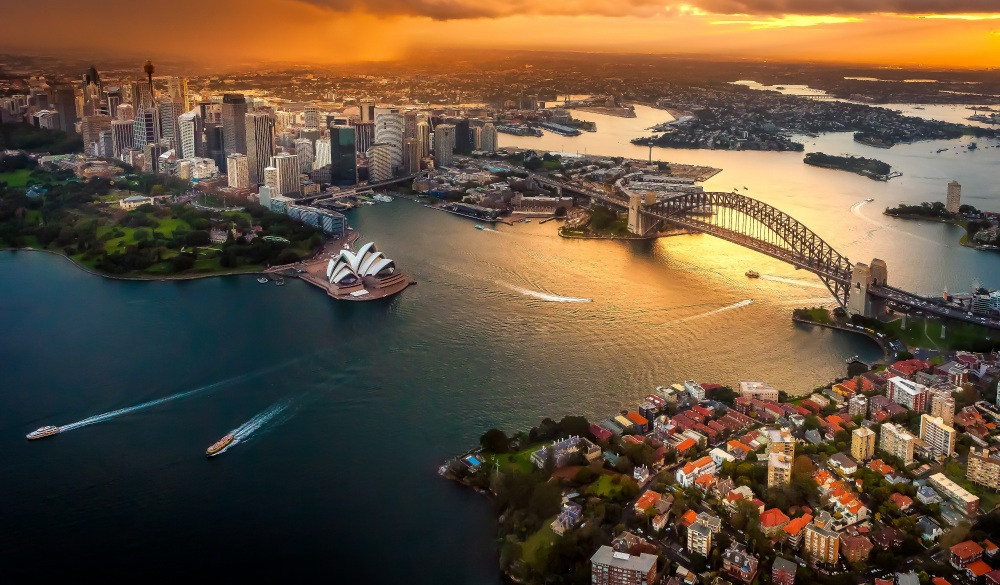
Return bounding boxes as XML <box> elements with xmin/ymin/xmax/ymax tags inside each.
<box><xmin>0</xmin><ymin>0</ymin><xmax>1000</xmax><ymax>69</ymax></box>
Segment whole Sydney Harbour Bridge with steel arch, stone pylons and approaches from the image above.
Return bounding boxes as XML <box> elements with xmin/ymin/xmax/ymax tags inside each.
<box><xmin>530</xmin><ymin>174</ymin><xmax>1000</xmax><ymax>328</ymax></box>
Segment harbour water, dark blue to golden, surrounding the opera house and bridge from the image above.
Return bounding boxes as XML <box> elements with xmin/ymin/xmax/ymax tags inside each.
<box><xmin>0</xmin><ymin>98</ymin><xmax>1000</xmax><ymax>584</ymax></box>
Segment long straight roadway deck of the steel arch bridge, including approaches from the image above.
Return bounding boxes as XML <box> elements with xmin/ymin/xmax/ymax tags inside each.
<box><xmin>532</xmin><ymin>173</ymin><xmax>1000</xmax><ymax>329</ymax></box>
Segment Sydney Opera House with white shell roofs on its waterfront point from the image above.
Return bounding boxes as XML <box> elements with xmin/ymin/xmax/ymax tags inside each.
<box><xmin>326</xmin><ymin>242</ymin><xmax>412</xmax><ymax>301</ymax></box>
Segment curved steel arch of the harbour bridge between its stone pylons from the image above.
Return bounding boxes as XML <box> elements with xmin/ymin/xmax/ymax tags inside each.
<box><xmin>640</xmin><ymin>192</ymin><xmax>853</xmax><ymax>309</ymax></box>
